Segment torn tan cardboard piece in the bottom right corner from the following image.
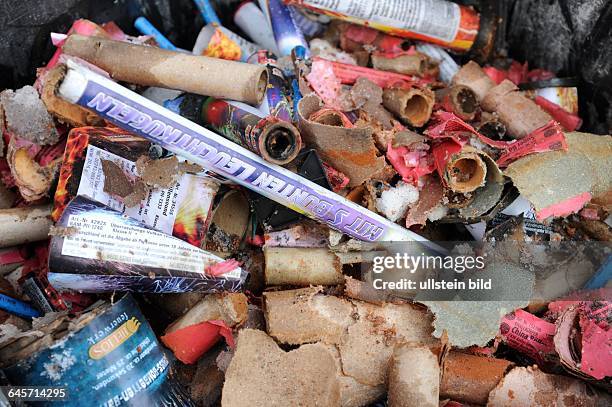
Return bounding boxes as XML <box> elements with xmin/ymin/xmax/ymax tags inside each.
<box><xmin>487</xmin><ymin>367</ymin><xmax>612</xmax><ymax>407</ymax></box>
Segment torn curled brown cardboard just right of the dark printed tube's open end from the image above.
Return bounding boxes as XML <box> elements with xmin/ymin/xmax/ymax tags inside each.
<box><xmin>298</xmin><ymin>95</ymin><xmax>385</xmax><ymax>187</ymax></box>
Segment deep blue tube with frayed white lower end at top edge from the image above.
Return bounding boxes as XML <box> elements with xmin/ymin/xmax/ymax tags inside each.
<box><xmin>265</xmin><ymin>0</ymin><xmax>309</xmax><ymax>57</ymax></box>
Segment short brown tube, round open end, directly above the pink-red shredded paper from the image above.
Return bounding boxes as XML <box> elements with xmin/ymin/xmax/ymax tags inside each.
<box><xmin>383</xmin><ymin>88</ymin><xmax>435</xmax><ymax>127</ymax></box>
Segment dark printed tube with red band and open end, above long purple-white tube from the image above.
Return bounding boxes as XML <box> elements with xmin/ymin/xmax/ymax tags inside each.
<box><xmin>170</xmin><ymin>94</ymin><xmax>302</xmax><ymax>165</ymax></box>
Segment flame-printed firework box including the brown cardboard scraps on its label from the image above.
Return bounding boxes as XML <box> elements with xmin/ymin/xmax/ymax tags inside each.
<box><xmin>53</xmin><ymin>127</ymin><xmax>219</xmax><ymax>247</ymax></box>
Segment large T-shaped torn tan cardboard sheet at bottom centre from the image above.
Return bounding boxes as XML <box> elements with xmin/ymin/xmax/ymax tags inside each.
<box><xmin>264</xmin><ymin>287</ymin><xmax>438</xmax><ymax>386</ymax></box>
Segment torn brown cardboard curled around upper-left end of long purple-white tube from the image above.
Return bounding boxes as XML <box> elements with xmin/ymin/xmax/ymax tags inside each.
<box><xmin>40</xmin><ymin>64</ymin><xmax>104</xmax><ymax>127</ymax></box>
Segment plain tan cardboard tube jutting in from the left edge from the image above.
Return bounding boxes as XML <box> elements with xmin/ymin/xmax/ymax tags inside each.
<box><xmin>0</xmin><ymin>205</ymin><xmax>52</xmax><ymax>248</ymax></box>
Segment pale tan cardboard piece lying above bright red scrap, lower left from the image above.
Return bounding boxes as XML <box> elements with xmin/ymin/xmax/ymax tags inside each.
<box><xmin>165</xmin><ymin>293</ymin><xmax>248</xmax><ymax>335</ymax></box>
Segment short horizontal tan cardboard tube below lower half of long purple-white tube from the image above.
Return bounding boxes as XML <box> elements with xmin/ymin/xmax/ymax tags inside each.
<box><xmin>264</xmin><ymin>247</ymin><xmax>344</xmax><ymax>286</ymax></box>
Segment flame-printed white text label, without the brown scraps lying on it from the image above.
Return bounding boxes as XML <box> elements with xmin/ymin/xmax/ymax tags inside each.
<box><xmin>52</xmin><ymin>127</ymin><xmax>219</xmax><ymax>247</ymax></box>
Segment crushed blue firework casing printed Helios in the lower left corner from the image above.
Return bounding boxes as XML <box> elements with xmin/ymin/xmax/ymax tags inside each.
<box><xmin>3</xmin><ymin>295</ymin><xmax>192</xmax><ymax>406</ymax></box>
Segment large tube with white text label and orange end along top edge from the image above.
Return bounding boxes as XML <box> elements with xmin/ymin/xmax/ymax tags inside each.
<box><xmin>284</xmin><ymin>0</ymin><xmax>480</xmax><ymax>51</ymax></box>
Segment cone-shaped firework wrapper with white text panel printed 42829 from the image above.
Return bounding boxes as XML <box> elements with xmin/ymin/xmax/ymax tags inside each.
<box><xmin>49</xmin><ymin>196</ymin><xmax>247</xmax><ymax>293</ymax></box>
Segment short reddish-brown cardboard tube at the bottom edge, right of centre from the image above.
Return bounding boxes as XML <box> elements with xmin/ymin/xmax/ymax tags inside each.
<box><xmin>440</xmin><ymin>352</ymin><xmax>513</xmax><ymax>405</ymax></box>
